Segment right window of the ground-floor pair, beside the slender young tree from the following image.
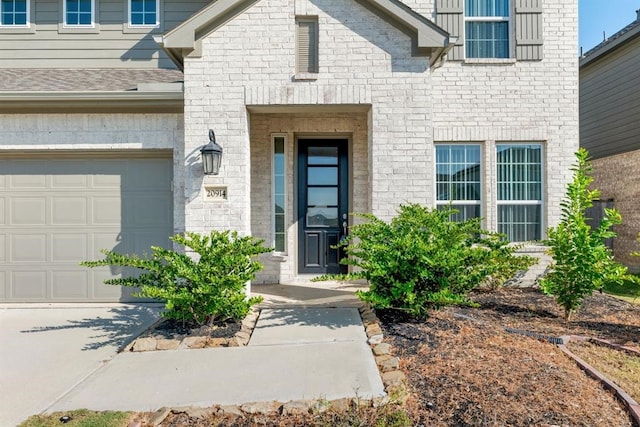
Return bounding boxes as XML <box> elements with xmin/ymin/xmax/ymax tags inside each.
<box><xmin>496</xmin><ymin>144</ymin><xmax>543</xmax><ymax>242</ymax></box>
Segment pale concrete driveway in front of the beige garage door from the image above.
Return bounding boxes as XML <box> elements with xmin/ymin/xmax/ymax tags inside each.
<box><xmin>0</xmin><ymin>304</ymin><xmax>161</xmax><ymax>427</ymax></box>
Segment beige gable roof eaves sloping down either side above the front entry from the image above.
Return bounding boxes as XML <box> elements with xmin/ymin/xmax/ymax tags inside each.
<box><xmin>155</xmin><ymin>0</ymin><xmax>455</xmax><ymax>69</ymax></box>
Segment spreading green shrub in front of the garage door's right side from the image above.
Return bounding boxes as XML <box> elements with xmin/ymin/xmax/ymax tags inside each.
<box><xmin>82</xmin><ymin>231</ymin><xmax>271</xmax><ymax>324</ymax></box>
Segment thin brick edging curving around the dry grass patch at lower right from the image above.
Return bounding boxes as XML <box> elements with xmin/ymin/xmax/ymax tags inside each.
<box><xmin>558</xmin><ymin>335</ymin><xmax>640</xmax><ymax>426</ymax></box>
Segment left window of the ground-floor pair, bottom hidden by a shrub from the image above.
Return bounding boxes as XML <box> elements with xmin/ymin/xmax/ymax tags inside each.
<box><xmin>436</xmin><ymin>144</ymin><xmax>482</xmax><ymax>221</ymax></box>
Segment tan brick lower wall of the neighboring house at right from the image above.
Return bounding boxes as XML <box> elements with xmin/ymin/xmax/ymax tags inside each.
<box><xmin>593</xmin><ymin>150</ymin><xmax>640</xmax><ymax>272</ymax></box>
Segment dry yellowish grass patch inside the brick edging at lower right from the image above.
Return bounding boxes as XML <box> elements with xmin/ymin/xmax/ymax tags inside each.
<box><xmin>567</xmin><ymin>341</ymin><xmax>640</xmax><ymax>402</ymax></box>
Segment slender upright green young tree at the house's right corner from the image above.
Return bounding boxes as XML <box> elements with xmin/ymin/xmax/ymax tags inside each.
<box><xmin>540</xmin><ymin>148</ymin><xmax>628</xmax><ymax>320</ymax></box>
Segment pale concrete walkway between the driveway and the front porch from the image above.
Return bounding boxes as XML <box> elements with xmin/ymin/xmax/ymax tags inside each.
<box><xmin>47</xmin><ymin>308</ymin><xmax>384</xmax><ymax>412</ymax></box>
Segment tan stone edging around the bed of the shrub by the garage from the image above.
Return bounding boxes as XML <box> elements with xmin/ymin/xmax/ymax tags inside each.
<box><xmin>122</xmin><ymin>307</ymin><xmax>260</xmax><ymax>352</ymax></box>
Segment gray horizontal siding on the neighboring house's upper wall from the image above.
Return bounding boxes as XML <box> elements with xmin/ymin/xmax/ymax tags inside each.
<box><xmin>580</xmin><ymin>37</ymin><xmax>640</xmax><ymax>158</ymax></box>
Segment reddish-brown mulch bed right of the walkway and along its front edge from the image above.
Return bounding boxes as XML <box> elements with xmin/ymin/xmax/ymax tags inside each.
<box><xmin>149</xmin><ymin>289</ymin><xmax>640</xmax><ymax>427</ymax></box>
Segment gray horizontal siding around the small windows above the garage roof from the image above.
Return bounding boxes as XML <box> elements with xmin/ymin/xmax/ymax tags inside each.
<box><xmin>0</xmin><ymin>0</ymin><xmax>211</xmax><ymax>68</ymax></box>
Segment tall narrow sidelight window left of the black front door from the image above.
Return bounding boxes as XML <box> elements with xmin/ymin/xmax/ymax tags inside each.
<box><xmin>271</xmin><ymin>135</ymin><xmax>287</xmax><ymax>252</ymax></box>
